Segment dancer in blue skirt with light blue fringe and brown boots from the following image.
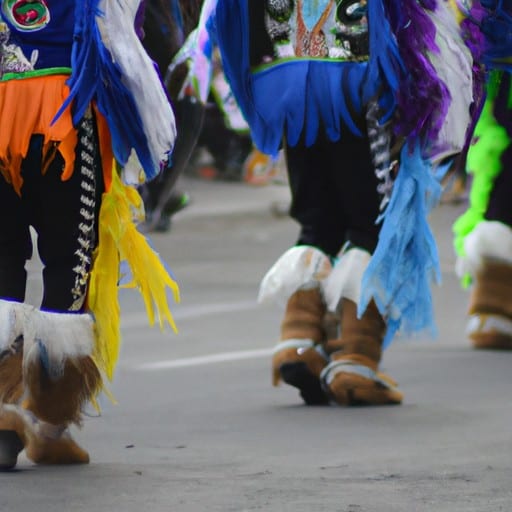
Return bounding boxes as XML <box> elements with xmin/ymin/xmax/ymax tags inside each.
<box><xmin>210</xmin><ymin>0</ymin><xmax>473</xmax><ymax>405</ymax></box>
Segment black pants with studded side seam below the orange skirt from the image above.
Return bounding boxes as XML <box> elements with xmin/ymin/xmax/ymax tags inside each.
<box><xmin>0</xmin><ymin>117</ymin><xmax>103</xmax><ymax>312</ymax></box>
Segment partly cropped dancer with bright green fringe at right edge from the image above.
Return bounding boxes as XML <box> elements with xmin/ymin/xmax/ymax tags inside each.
<box><xmin>454</xmin><ymin>1</ymin><xmax>512</xmax><ymax>350</ymax></box>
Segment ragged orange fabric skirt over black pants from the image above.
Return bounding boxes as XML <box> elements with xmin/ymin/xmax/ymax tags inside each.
<box><xmin>0</xmin><ymin>75</ymin><xmax>113</xmax><ymax>194</ymax></box>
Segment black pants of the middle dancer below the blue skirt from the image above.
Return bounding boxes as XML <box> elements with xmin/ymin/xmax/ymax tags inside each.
<box><xmin>286</xmin><ymin>129</ymin><xmax>381</xmax><ymax>257</ymax></box>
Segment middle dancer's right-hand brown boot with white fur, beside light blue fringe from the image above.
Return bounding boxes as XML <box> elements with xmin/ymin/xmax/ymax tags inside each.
<box><xmin>321</xmin><ymin>247</ymin><xmax>403</xmax><ymax>405</ymax></box>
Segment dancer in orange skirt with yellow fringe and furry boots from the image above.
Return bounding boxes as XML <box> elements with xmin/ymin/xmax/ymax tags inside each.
<box><xmin>0</xmin><ymin>0</ymin><xmax>179</xmax><ymax>469</ymax></box>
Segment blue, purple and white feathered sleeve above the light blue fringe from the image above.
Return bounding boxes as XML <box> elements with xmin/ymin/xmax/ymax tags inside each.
<box><xmin>369</xmin><ymin>0</ymin><xmax>475</xmax><ymax>160</ymax></box>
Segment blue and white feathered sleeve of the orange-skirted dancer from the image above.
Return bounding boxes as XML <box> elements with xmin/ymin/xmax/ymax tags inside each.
<box><xmin>57</xmin><ymin>0</ymin><xmax>176</xmax><ymax>183</ymax></box>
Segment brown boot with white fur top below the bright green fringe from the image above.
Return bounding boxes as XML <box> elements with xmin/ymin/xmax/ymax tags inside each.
<box><xmin>458</xmin><ymin>221</ymin><xmax>512</xmax><ymax>350</ymax></box>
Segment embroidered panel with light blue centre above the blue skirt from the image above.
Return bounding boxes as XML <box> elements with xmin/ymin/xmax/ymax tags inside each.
<box><xmin>263</xmin><ymin>0</ymin><xmax>368</xmax><ymax>61</ymax></box>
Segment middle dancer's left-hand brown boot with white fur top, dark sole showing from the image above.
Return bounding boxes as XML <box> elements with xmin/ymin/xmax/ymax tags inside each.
<box><xmin>260</xmin><ymin>246</ymin><xmax>331</xmax><ymax>405</ymax></box>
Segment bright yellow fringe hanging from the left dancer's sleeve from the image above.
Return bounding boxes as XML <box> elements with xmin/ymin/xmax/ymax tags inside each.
<box><xmin>88</xmin><ymin>171</ymin><xmax>180</xmax><ymax>379</ymax></box>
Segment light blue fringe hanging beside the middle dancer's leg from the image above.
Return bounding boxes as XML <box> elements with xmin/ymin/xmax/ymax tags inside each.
<box><xmin>358</xmin><ymin>146</ymin><xmax>441</xmax><ymax>348</ymax></box>
